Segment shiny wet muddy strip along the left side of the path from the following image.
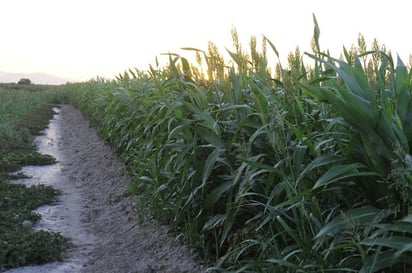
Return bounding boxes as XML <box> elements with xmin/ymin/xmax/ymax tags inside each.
<box><xmin>6</xmin><ymin>108</ymin><xmax>95</xmax><ymax>273</ymax></box>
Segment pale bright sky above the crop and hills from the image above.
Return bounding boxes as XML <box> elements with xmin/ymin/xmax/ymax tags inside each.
<box><xmin>0</xmin><ymin>0</ymin><xmax>412</xmax><ymax>81</ymax></box>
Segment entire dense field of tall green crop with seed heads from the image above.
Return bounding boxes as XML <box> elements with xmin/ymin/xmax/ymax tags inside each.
<box><xmin>65</xmin><ymin>19</ymin><xmax>412</xmax><ymax>273</ymax></box>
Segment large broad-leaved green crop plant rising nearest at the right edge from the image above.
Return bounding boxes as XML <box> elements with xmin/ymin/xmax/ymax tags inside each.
<box><xmin>305</xmin><ymin>52</ymin><xmax>411</xmax><ymax>212</ymax></box>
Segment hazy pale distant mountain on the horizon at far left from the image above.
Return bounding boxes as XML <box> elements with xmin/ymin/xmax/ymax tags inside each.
<box><xmin>0</xmin><ymin>71</ymin><xmax>76</xmax><ymax>84</ymax></box>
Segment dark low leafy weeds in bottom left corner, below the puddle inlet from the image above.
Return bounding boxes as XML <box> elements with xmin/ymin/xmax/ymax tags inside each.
<box><xmin>0</xmin><ymin>180</ymin><xmax>67</xmax><ymax>268</ymax></box>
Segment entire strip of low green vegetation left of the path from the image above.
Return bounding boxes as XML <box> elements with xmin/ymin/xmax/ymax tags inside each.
<box><xmin>0</xmin><ymin>84</ymin><xmax>67</xmax><ymax>271</ymax></box>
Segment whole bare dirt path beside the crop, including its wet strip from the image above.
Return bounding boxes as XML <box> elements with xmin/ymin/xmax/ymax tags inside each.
<box><xmin>7</xmin><ymin>105</ymin><xmax>205</xmax><ymax>273</ymax></box>
